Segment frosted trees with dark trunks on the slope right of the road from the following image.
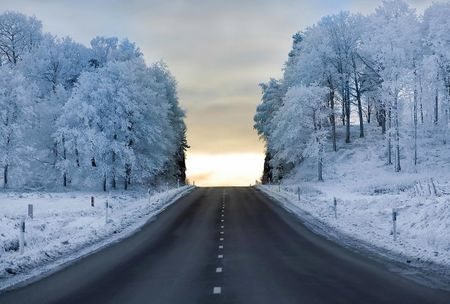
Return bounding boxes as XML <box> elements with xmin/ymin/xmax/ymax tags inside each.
<box><xmin>254</xmin><ymin>0</ymin><xmax>450</xmax><ymax>182</ymax></box>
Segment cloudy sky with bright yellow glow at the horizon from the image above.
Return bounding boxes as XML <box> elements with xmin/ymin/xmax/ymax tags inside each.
<box><xmin>0</xmin><ymin>0</ymin><xmax>432</xmax><ymax>186</ymax></box>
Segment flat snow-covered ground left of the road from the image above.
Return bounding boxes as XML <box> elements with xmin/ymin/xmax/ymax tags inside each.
<box><xmin>0</xmin><ymin>187</ymin><xmax>191</xmax><ymax>289</ymax></box>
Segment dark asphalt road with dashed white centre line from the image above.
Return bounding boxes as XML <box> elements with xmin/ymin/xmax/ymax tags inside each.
<box><xmin>0</xmin><ymin>188</ymin><xmax>450</xmax><ymax>304</ymax></box>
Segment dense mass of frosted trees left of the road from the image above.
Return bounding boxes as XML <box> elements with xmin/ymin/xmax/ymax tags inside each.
<box><xmin>0</xmin><ymin>12</ymin><xmax>188</xmax><ymax>190</ymax></box>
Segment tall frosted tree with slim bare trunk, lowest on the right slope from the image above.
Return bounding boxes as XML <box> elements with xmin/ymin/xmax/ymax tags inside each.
<box><xmin>363</xmin><ymin>1</ymin><xmax>419</xmax><ymax>172</ymax></box>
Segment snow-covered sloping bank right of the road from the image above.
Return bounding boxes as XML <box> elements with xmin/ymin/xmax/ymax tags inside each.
<box><xmin>260</xmin><ymin>125</ymin><xmax>450</xmax><ymax>288</ymax></box>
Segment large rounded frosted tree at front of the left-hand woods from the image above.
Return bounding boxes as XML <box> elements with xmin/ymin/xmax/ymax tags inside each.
<box><xmin>55</xmin><ymin>58</ymin><xmax>184</xmax><ymax>190</ymax></box>
